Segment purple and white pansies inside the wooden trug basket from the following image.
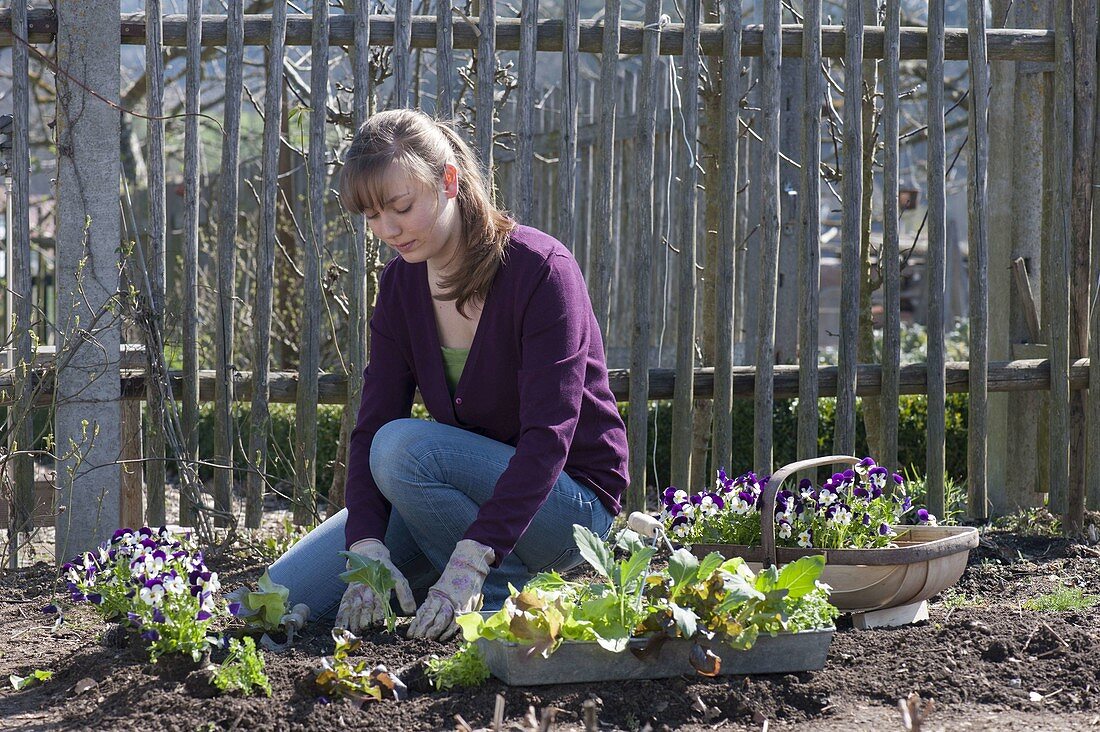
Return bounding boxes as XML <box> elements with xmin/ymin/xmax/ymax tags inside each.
<box><xmin>661</xmin><ymin>458</ymin><xmax>936</xmax><ymax>549</ymax></box>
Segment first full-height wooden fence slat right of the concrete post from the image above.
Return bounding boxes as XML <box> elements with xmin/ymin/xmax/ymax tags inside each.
<box><xmin>145</xmin><ymin>0</ymin><xmax>166</xmax><ymax>526</ymax></box>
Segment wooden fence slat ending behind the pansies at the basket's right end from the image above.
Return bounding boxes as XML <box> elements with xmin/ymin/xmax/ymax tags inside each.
<box><xmin>881</xmin><ymin>0</ymin><xmax>901</xmax><ymax>477</ymax></box>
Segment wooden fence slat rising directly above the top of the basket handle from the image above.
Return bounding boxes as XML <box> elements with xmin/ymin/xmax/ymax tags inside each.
<box><xmin>796</xmin><ymin>0</ymin><xmax>823</xmax><ymax>472</ymax></box>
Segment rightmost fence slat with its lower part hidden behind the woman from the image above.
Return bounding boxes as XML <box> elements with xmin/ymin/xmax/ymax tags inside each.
<box><xmin>586</xmin><ymin>0</ymin><xmax>625</xmax><ymax>328</ymax></box>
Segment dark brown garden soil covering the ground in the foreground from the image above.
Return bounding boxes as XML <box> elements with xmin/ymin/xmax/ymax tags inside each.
<box><xmin>0</xmin><ymin>533</ymin><xmax>1100</xmax><ymax>732</ymax></box>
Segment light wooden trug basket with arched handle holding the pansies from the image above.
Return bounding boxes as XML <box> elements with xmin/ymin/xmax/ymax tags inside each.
<box><xmin>691</xmin><ymin>456</ymin><xmax>979</xmax><ymax>612</ymax></box>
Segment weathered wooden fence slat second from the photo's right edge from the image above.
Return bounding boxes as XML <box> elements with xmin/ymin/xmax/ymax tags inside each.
<box><xmin>1043</xmin><ymin>0</ymin><xmax>1074</xmax><ymax>515</ymax></box>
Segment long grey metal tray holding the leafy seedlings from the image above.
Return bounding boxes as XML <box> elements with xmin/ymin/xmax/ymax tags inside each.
<box><xmin>477</xmin><ymin>629</ymin><xmax>833</xmax><ymax>686</ymax></box>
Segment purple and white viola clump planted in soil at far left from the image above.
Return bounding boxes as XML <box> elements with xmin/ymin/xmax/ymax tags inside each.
<box><xmin>62</xmin><ymin>526</ymin><xmax>227</xmax><ymax>663</ymax></box>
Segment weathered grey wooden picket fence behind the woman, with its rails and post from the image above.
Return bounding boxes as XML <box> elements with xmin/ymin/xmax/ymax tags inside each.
<box><xmin>0</xmin><ymin>0</ymin><xmax>1100</xmax><ymax>556</ymax></box>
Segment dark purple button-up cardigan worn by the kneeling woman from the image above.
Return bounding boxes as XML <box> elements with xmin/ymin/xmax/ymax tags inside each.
<box><xmin>345</xmin><ymin>226</ymin><xmax>628</xmax><ymax>566</ymax></box>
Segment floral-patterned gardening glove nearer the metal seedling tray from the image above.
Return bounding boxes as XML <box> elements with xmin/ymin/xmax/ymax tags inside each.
<box><xmin>408</xmin><ymin>539</ymin><xmax>496</xmax><ymax>641</ymax></box>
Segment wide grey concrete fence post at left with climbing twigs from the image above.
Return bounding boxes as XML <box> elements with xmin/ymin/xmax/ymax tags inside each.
<box><xmin>54</xmin><ymin>0</ymin><xmax>121</xmax><ymax>561</ymax></box>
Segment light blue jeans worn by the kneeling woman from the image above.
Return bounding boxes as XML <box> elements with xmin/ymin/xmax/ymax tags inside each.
<box><xmin>262</xmin><ymin>419</ymin><xmax>614</xmax><ymax>619</ymax></box>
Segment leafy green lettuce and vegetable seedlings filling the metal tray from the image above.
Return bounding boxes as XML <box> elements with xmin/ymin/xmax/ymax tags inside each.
<box><xmin>458</xmin><ymin>526</ymin><xmax>836</xmax><ymax>675</ymax></box>
